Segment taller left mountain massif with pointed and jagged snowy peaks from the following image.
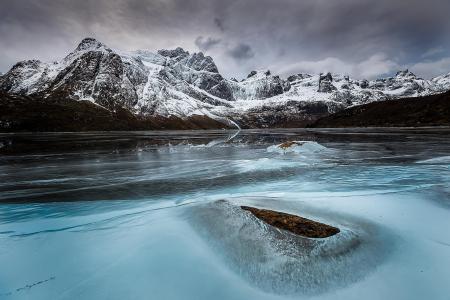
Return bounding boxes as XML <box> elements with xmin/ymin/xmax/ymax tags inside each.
<box><xmin>0</xmin><ymin>38</ymin><xmax>234</xmax><ymax>117</ymax></box>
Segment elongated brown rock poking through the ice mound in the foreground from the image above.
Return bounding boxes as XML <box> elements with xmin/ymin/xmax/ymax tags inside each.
<box><xmin>241</xmin><ymin>206</ymin><xmax>340</xmax><ymax>238</ymax></box>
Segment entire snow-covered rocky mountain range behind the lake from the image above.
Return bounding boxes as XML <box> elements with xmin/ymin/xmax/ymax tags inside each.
<box><xmin>0</xmin><ymin>38</ymin><xmax>450</xmax><ymax>127</ymax></box>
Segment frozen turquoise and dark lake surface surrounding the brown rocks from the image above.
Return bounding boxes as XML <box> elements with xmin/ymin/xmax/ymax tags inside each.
<box><xmin>0</xmin><ymin>128</ymin><xmax>450</xmax><ymax>300</ymax></box>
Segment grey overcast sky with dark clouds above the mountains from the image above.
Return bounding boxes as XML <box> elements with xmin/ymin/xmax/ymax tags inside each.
<box><xmin>0</xmin><ymin>0</ymin><xmax>450</xmax><ymax>78</ymax></box>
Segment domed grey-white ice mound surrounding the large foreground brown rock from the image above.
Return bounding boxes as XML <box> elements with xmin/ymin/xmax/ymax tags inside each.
<box><xmin>186</xmin><ymin>199</ymin><xmax>392</xmax><ymax>295</ymax></box>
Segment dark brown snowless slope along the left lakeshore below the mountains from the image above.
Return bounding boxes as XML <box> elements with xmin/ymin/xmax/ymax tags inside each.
<box><xmin>0</xmin><ymin>93</ymin><xmax>228</xmax><ymax>132</ymax></box>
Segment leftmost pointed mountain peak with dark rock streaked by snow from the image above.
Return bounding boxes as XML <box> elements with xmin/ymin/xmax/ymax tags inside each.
<box><xmin>0</xmin><ymin>38</ymin><xmax>142</xmax><ymax>110</ymax></box>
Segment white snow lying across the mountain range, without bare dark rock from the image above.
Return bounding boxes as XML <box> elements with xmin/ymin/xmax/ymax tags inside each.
<box><xmin>3</xmin><ymin>39</ymin><xmax>450</xmax><ymax>121</ymax></box>
